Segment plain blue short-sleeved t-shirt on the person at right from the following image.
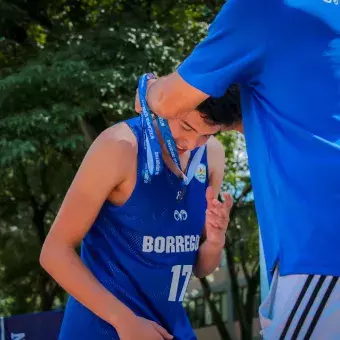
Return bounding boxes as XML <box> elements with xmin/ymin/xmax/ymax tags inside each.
<box><xmin>178</xmin><ymin>0</ymin><xmax>340</xmax><ymax>277</ymax></box>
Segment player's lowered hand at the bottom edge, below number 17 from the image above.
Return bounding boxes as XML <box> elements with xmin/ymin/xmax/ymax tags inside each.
<box><xmin>117</xmin><ymin>316</ymin><xmax>173</xmax><ymax>340</ymax></box>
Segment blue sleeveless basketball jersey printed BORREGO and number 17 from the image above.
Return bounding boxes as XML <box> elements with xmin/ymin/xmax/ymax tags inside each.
<box><xmin>59</xmin><ymin>117</ymin><xmax>208</xmax><ymax>340</ymax></box>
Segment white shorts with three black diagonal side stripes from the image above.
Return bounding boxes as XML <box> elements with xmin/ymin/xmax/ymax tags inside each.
<box><xmin>259</xmin><ymin>270</ymin><xmax>340</xmax><ymax>340</ymax></box>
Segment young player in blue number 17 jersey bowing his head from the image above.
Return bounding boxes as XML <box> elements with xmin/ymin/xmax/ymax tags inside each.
<box><xmin>40</xmin><ymin>88</ymin><xmax>240</xmax><ymax>340</ymax></box>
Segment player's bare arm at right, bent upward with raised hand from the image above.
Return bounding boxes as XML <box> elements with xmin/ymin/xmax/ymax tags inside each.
<box><xmin>194</xmin><ymin>138</ymin><xmax>232</xmax><ymax>277</ymax></box>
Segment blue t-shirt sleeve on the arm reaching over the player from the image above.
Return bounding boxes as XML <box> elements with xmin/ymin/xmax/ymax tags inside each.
<box><xmin>177</xmin><ymin>0</ymin><xmax>268</xmax><ymax>97</ymax></box>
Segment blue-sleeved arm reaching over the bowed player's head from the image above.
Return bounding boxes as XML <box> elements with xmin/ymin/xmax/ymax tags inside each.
<box><xmin>143</xmin><ymin>0</ymin><xmax>268</xmax><ymax>118</ymax></box>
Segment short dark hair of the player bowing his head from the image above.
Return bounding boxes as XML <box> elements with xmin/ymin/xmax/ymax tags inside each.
<box><xmin>196</xmin><ymin>84</ymin><xmax>242</xmax><ymax>126</ymax></box>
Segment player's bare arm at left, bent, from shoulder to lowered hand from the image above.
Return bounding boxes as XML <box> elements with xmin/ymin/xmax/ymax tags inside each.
<box><xmin>40</xmin><ymin>124</ymin><xmax>172</xmax><ymax>340</ymax></box>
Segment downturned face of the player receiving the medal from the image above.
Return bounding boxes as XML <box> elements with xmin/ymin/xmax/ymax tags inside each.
<box><xmin>169</xmin><ymin>111</ymin><xmax>221</xmax><ymax>154</ymax></box>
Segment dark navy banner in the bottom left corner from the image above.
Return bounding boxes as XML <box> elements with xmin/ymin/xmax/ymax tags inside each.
<box><xmin>0</xmin><ymin>311</ymin><xmax>64</xmax><ymax>340</ymax></box>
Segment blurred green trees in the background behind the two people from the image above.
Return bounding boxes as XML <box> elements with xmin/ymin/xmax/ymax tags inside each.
<box><xmin>0</xmin><ymin>0</ymin><xmax>258</xmax><ymax>339</ymax></box>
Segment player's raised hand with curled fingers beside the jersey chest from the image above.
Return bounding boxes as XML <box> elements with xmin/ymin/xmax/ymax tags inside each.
<box><xmin>205</xmin><ymin>187</ymin><xmax>233</xmax><ymax>247</ymax></box>
